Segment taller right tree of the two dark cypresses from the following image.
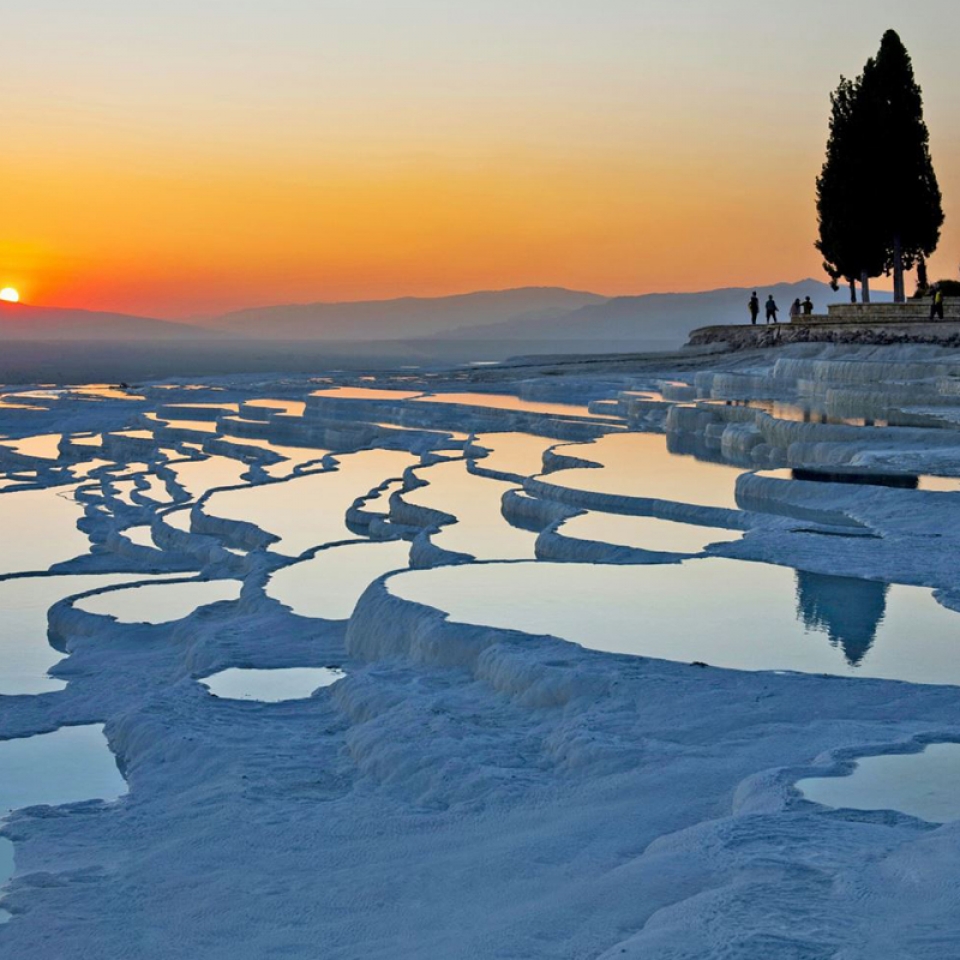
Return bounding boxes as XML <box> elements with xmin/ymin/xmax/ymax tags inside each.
<box><xmin>859</xmin><ymin>30</ymin><xmax>943</xmax><ymax>302</ymax></box>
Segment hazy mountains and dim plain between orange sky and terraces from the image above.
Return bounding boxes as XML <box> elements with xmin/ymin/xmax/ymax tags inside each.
<box><xmin>0</xmin><ymin>280</ymin><xmax>872</xmax><ymax>383</ymax></box>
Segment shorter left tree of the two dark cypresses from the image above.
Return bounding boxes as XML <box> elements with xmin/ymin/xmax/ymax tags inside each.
<box><xmin>816</xmin><ymin>77</ymin><xmax>886</xmax><ymax>302</ymax></box>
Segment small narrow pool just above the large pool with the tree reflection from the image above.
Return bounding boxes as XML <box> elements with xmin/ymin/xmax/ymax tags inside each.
<box><xmin>559</xmin><ymin>510</ymin><xmax>743</xmax><ymax>553</ymax></box>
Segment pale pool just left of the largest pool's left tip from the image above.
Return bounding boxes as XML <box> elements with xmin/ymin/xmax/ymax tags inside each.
<box><xmin>267</xmin><ymin>540</ymin><xmax>410</xmax><ymax>620</ymax></box>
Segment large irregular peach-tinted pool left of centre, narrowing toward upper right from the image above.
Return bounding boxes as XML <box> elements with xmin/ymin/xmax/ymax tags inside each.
<box><xmin>204</xmin><ymin>450</ymin><xmax>418</xmax><ymax>557</ymax></box>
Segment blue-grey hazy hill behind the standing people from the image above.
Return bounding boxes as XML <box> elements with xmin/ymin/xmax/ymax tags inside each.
<box><xmin>436</xmin><ymin>280</ymin><xmax>876</xmax><ymax>352</ymax></box>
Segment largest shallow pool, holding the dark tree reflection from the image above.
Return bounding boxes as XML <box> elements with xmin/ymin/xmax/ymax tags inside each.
<box><xmin>389</xmin><ymin>558</ymin><xmax>960</xmax><ymax>685</ymax></box>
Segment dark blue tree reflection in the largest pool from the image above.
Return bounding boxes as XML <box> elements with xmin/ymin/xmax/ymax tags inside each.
<box><xmin>797</xmin><ymin>570</ymin><xmax>889</xmax><ymax>667</ymax></box>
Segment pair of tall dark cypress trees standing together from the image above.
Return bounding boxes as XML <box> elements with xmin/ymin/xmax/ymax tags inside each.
<box><xmin>817</xmin><ymin>30</ymin><xmax>943</xmax><ymax>301</ymax></box>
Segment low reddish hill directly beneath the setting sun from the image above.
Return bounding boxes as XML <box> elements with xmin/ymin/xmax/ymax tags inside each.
<box><xmin>0</xmin><ymin>302</ymin><xmax>221</xmax><ymax>342</ymax></box>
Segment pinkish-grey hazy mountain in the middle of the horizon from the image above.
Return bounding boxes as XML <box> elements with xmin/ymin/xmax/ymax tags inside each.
<box><xmin>204</xmin><ymin>287</ymin><xmax>606</xmax><ymax>341</ymax></box>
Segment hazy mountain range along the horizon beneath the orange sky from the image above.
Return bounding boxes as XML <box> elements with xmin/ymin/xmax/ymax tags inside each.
<box><xmin>0</xmin><ymin>280</ymin><xmax>889</xmax><ymax>358</ymax></box>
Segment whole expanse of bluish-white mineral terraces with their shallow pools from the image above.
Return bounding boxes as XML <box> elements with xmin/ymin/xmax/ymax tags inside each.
<box><xmin>0</xmin><ymin>344</ymin><xmax>960</xmax><ymax>960</ymax></box>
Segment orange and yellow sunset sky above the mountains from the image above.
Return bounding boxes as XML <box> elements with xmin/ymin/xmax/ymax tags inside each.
<box><xmin>0</xmin><ymin>0</ymin><xmax>960</xmax><ymax>317</ymax></box>
